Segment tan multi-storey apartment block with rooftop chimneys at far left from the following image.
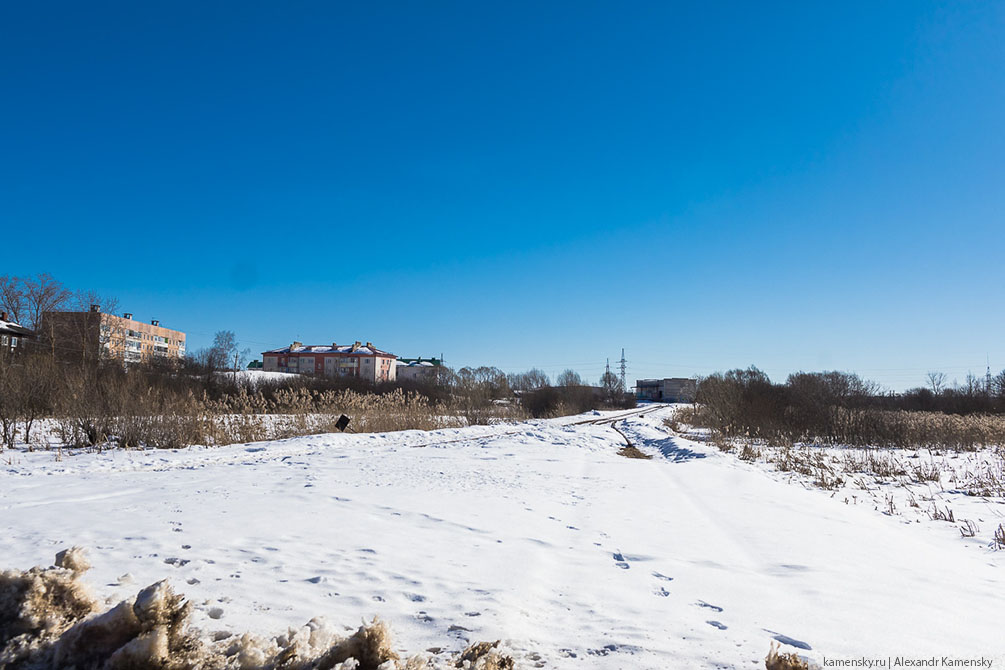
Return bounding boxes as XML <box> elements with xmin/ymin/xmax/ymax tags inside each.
<box><xmin>38</xmin><ymin>304</ymin><xmax>185</xmax><ymax>364</ymax></box>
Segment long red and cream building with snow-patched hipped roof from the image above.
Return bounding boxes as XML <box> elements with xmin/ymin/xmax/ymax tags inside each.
<box><xmin>261</xmin><ymin>342</ymin><xmax>398</xmax><ymax>383</ymax></box>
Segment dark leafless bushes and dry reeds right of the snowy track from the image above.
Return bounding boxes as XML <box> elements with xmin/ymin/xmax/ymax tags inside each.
<box><xmin>679</xmin><ymin>367</ymin><xmax>1005</xmax><ymax>449</ymax></box>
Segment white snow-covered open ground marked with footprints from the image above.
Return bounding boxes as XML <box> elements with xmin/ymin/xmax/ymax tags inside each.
<box><xmin>0</xmin><ymin>409</ymin><xmax>1005</xmax><ymax>668</ymax></box>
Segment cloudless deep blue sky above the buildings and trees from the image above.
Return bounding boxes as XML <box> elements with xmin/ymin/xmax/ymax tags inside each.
<box><xmin>0</xmin><ymin>1</ymin><xmax>1005</xmax><ymax>389</ymax></box>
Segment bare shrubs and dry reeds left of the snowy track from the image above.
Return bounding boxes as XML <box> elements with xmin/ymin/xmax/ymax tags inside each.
<box><xmin>0</xmin><ymin>353</ymin><xmax>633</xmax><ymax>449</ymax></box>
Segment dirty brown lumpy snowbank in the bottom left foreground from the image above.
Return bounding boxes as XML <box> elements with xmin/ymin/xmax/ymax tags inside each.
<box><xmin>0</xmin><ymin>547</ymin><xmax>514</xmax><ymax>670</ymax></box>
